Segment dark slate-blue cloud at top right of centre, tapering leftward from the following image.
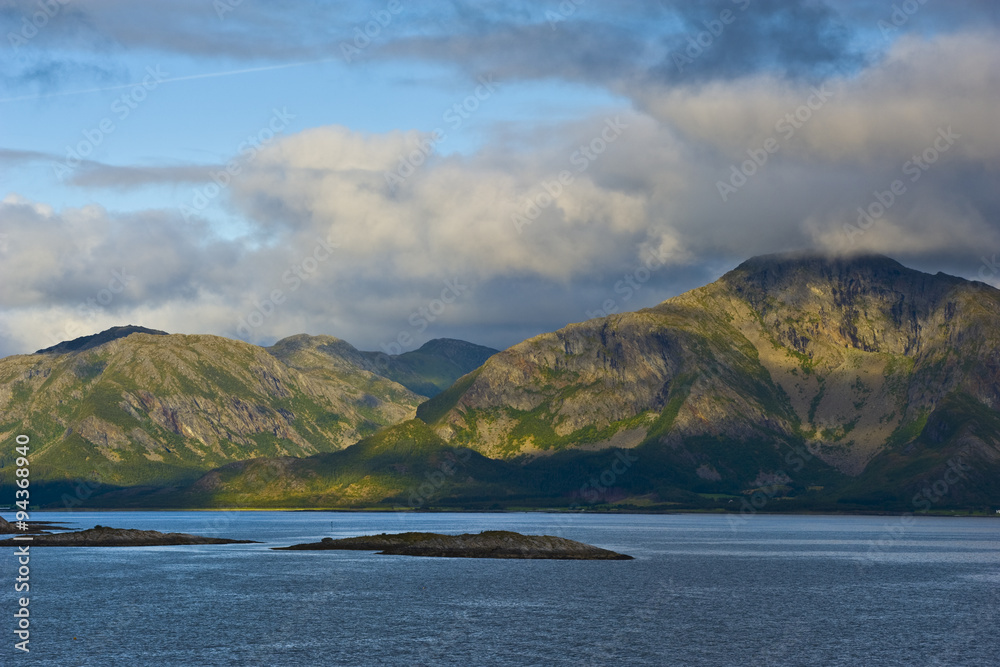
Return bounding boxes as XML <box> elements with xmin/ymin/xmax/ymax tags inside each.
<box><xmin>374</xmin><ymin>0</ymin><xmax>867</xmax><ymax>88</ymax></box>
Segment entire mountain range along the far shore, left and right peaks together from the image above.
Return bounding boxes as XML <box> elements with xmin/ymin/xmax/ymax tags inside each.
<box><xmin>0</xmin><ymin>254</ymin><xmax>1000</xmax><ymax>513</ymax></box>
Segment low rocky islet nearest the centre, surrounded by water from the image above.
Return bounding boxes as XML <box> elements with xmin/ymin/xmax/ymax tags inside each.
<box><xmin>272</xmin><ymin>530</ymin><xmax>632</xmax><ymax>560</ymax></box>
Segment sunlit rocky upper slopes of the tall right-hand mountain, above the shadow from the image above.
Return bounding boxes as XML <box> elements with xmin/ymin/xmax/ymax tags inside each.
<box><xmin>418</xmin><ymin>250</ymin><xmax>1000</xmax><ymax>478</ymax></box>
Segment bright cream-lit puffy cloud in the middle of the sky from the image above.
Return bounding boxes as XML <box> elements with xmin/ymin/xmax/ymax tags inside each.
<box><xmin>234</xmin><ymin>118</ymin><xmax>675</xmax><ymax>280</ymax></box>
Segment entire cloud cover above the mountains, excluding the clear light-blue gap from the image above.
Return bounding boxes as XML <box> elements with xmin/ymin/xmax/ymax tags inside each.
<box><xmin>0</xmin><ymin>0</ymin><xmax>1000</xmax><ymax>354</ymax></box>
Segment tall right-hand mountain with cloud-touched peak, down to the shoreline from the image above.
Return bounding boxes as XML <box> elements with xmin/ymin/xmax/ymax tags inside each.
<box><xmin>154</xmin><ymin>254</ymin><xmax>1000</xmax><ymax>511</ymax></box>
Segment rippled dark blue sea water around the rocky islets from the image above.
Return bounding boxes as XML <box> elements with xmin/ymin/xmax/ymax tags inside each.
<box><xmin>0</xmin><ymin>512</ymin><xmax>1000</xmax><ymax>667</ymax></box>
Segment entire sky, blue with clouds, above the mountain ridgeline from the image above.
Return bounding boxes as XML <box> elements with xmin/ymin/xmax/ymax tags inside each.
<box><xmin>0</xmin><ymin>0</ymin><xmax>1000</xmax><ymax>356</ymax></box>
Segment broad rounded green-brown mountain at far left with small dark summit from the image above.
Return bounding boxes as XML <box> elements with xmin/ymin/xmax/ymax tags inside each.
<box><xmin>0</xmin><ymin>327</ymin><xmax>424</xmax><ymax>496</ymax></box>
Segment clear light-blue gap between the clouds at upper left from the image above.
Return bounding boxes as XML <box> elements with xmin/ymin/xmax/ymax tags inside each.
<box><xmin>3</xmin><ymin>56</ymin><xmax>622</xmax><ymax>235</ymax></box>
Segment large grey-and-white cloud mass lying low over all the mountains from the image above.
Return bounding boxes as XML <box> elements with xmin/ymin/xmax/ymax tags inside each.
<box><xmin>0</xmin><ymin>32</ymin><xmax>1000</xmax><ymax>360</ymax></box>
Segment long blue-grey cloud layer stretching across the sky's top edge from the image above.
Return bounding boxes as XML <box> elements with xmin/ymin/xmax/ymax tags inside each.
<box><xmin>0</xmin><ymin>0</ymin><xmax>1000</xmax><ymax>95</ymax></box>
